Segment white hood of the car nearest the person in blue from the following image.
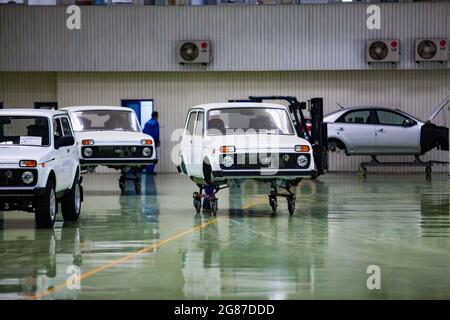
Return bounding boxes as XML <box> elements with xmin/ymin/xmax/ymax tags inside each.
<box><xmin>75</xmin><ymin>131</ymin><xmax>152</xmax><ymax>144</ymax></box>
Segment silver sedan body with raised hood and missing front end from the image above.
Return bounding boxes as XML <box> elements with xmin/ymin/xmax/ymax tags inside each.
<box><xmin>324</xmin><ymin>99</ymin><xmax>448</xmax><ymax>156</ymax></box>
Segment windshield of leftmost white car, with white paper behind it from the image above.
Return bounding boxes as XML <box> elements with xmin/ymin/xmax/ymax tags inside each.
<box><xmin>0</xmin><ymin>116</ymin><xmax>50</xmax><ymax>147</ymax></box>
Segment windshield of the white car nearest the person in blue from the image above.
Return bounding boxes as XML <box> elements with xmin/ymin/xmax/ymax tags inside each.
<box><xmin>72</xmin><ymin>110</ymin><xmax>139</xmax><ymax>132</ymax></box>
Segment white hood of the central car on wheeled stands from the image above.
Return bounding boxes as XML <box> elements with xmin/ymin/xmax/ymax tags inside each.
<box><xmin>204</xmin><ymin>134</ymin><xmax>311</xmax><ymax>151</ymax></box>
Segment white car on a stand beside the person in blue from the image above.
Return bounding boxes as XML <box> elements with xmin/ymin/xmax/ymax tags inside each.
<box><xmin>62</xmin><ymin>106</ymin><xmax>157</xmax><ymax>193</ymax></box>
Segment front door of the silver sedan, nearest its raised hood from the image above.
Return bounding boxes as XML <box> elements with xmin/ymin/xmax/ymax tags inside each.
<box><xmin>375</xmin><ymin>109</ymin><xmax>420</xmax><ymax>154</ymax></box>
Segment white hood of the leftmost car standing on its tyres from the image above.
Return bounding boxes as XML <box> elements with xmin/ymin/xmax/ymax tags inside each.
<box><xmin>0</xmin><ymin>146</ymin><xmax>50</xmax><ymax>164</ymax></box>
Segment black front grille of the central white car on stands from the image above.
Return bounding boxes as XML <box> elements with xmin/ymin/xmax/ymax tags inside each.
<box><xmin>220</xmin><ymin>153</ymin><xmax>310</xmax><ymax>170</ymax></box>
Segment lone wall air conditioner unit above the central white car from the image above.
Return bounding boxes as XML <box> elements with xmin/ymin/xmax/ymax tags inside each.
<box><xmin>177</xmin><ymin>40</ymin><xmax>211</xmax><ymax>64</ymax></box>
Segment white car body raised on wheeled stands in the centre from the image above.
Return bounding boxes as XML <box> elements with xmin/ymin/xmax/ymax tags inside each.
<box><xmin>178</xmin><ymin>102</ymin><xmax>317</xmax><ymax>185</ymax></box>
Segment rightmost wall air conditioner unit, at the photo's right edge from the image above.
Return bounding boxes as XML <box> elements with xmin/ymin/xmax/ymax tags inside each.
<box><xmin>415</xmin><ymin>38</ymin><xmax>448</xmax><ymax>62</ymax></box>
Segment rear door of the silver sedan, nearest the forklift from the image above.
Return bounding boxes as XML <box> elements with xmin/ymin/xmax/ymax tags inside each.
<box><xmin>331</xmin><ymin>109</ymin><xmax>376</xmax><ymax>154</ymax></box>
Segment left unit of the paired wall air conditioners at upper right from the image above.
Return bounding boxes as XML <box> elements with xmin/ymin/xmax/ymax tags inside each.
<box><xmin>366</xmin><ymin>39</ymin><xmax>400</xmax><ymax>63</ymax></box>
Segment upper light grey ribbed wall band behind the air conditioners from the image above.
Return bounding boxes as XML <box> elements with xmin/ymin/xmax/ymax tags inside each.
<box><xmin>0</xmin><ymin>2</ymin><xmax>450</xmax><ymax>72</ymax></box>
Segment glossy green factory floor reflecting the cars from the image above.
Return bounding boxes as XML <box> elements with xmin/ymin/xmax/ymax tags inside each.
<box><xmin>0</xmin><ymin>173</ymin><xmax>450</xmax><ymax>299</ymax></box>
